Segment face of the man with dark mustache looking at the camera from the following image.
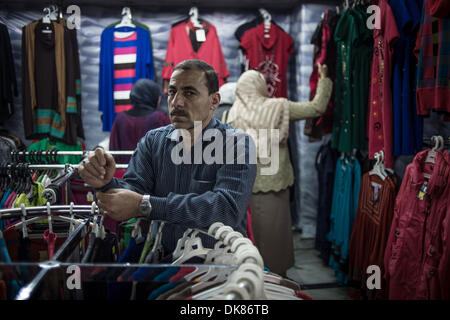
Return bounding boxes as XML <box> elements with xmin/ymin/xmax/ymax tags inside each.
<box><xmin>167</xmin><ymin>70</ymin><xmax>220</xmax><ymax>130</ymax></box>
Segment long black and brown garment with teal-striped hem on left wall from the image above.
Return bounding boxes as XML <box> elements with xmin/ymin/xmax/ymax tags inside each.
<box><xmin>22</xmin><ymin>20</ymin><xmax>84</xmax><ymax>144</ymax></box>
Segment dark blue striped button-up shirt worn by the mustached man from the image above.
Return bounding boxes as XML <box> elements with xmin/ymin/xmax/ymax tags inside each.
<box><xmin>102</xmin><ymin>118</ymin><xmax>257</xmax><ymax>252</ymax></box>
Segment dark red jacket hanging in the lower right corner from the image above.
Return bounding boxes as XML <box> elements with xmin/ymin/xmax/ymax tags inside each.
<box><xmin>384</xmin><ymin>151</ymin><xmax>450</xmax><ymax>300</ymax></box>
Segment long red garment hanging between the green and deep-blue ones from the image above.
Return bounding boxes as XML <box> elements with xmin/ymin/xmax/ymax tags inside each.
<box><xmin>367</xmin><ymin>0</ymin><xmax>399</xmax><ymax>168</ymax></box>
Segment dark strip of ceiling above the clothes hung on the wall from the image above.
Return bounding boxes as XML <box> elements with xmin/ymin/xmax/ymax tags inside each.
<box><xmin>0</xmin><ymin>0</ymin><xmax>341</xmax><ymax>11</ymax></box>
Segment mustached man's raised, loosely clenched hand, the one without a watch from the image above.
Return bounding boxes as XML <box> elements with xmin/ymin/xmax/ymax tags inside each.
<box><xmin>78</xmin><ymin>148</ymin><xmax>116</xmax><ymax>188</ymax></box>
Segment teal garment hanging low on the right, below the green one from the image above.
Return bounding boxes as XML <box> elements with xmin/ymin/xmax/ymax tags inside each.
<box><xmin>327</xmin><ymin>158</ymin><xmax>361</xmax><ymax>285</ymax></box>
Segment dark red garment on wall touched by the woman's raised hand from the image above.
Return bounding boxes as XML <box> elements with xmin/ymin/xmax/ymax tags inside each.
<box><xmin>304</xmin><ymin>9</ymin><xmax>340</xmax><ymax>142</ymax></box>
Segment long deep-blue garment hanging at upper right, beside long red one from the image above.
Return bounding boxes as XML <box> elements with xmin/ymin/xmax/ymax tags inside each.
<box><xmin>389</xmin><ymin>0</ymin><xmax>423</xmax><ymax>156</ymax></box>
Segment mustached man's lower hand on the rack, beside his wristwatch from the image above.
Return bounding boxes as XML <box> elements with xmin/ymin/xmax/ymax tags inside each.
<box><xmin>97</xmin><ymin>189</ymin><xmax>142</xmax><ymax>221</ymax></box>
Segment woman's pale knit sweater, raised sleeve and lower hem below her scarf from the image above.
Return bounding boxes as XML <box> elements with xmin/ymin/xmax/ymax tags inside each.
<box><xmin>253</xmin><ymin>78</ymin><xmax>333</xmax><ymax>193</ymax></box>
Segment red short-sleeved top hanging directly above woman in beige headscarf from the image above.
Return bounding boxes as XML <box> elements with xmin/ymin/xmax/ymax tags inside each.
<box><xmin>241</xmin><ymin>23</ymin><xmax>294</xmax><ymax>98</ymax></box>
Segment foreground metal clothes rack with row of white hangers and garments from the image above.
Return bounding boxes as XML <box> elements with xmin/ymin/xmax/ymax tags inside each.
<box><xmin>0</xmin><ymin>203</ymin><xmax>301</xmax><ymax>300</ymax></box>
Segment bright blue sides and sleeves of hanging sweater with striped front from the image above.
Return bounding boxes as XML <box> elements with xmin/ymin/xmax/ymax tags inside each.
<box><xmin>98</xmin><ymin>25</ymin><xmax>154</xmax><ymax>131</ymax></box>
